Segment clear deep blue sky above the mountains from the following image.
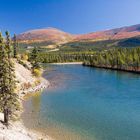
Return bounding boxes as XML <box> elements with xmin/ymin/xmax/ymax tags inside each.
<box><xmin>0</xmin><ymin>0</ymin><xmax>140</xmax><ymax>34</ymax></box>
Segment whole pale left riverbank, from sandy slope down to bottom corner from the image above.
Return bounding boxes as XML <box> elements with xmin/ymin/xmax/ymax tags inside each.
<box><xmin>0</xmin><ymin>61</ymin><xmax>52</xmax><ymax>140</ymax></box>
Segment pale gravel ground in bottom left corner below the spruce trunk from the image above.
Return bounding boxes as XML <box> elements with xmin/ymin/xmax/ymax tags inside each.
<box><xmin>0</xmin><ymin>113</ymin><xmax>52</xmax><ymax>140</ymax></box>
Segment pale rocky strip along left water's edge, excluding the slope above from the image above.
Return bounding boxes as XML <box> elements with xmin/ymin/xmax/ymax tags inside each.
<box><xmin>0</xmin><ymin>80</ymin><xmax>52</xmax><ymax>140</ymax></box>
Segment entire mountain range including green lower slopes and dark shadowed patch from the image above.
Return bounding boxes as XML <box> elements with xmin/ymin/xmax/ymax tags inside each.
<box><xmin>17</xmin><ymin>24</ymin><xmax>140</xmax><ymax>50</ymax></box>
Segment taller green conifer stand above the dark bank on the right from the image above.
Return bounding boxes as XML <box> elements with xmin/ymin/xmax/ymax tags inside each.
<box><xmin>84</xmin><ymin>48</ymin><xmax>140</xmax><ymax>72</ymax></box>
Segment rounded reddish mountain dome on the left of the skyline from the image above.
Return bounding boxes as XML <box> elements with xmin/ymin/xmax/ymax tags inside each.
<box><xmin>17</xmin><ymin>28</ymin><xmax>72</xmax><ymax>44</ymax></box>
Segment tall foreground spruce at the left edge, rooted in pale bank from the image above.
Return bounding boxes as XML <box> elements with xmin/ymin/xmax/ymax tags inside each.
<box><xmin>0</xmin><ymin>32</ymin><xmax>19</xmax><ymax>125</ymax></box>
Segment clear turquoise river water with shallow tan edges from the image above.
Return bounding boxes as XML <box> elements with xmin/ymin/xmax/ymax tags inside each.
<box><xmin>23</xmin><ymin>65</ymin><xmax>140</xmax><ymax>140</ymax></box>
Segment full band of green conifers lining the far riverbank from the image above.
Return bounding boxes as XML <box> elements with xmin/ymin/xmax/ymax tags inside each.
<box><xmin>29</xmin><ymin>47</ymin><xmax>140</xmax><ymax>72</ymax></box>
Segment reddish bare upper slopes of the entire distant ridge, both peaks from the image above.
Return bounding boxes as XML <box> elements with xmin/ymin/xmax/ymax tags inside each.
<box><xmin>17</xmin><ymin>24</ymin><xmax>140</xmax><ymax>44</ymax></box>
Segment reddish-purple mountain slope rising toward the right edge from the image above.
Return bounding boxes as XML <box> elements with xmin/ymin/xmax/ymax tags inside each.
<box><xmin>75</xmin><ymin>24</ymin><xmax>140</xmax><ymax>41</ymax></box>
